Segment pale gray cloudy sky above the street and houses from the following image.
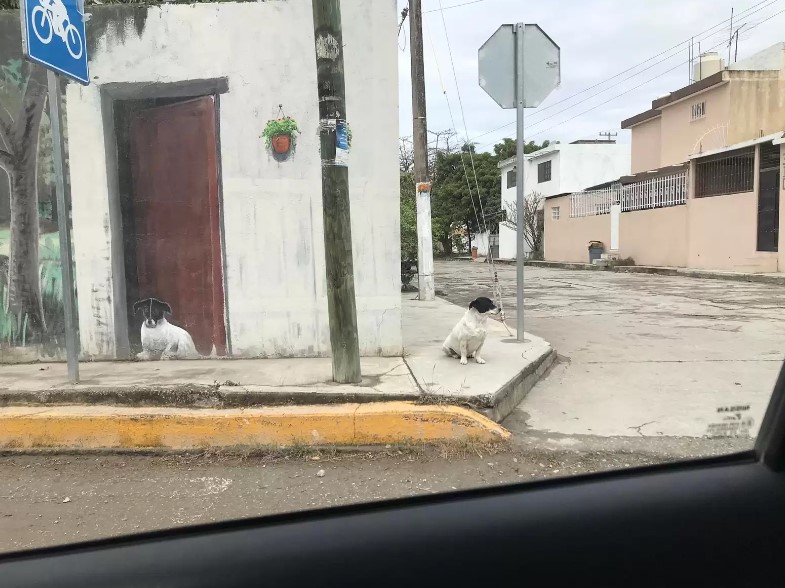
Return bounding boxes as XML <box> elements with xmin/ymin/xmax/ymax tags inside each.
<box><xmin>398</xmin><ymin>0</ymin><xmax>785</xmax><ymax>150</ymax></box>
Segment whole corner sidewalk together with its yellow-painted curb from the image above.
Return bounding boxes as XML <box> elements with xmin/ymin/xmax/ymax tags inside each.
<box><xmin>0</xmin><ymin>296</ymin><xmax>555</xmax><ymax>449</ymax></box>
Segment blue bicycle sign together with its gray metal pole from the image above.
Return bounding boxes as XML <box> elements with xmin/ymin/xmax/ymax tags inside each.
<box><xmin>19</xmin><ymin>0</ymin><xmax>90</xmax><ymax>384</ymax></box>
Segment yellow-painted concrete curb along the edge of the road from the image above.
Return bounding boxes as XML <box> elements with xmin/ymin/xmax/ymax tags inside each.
<box><xmin>0</xmin><ymin>402</ymin><xmax>510</xmax><ymax>449</ymax></box>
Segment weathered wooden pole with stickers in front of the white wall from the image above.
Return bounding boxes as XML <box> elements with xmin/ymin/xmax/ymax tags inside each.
<box><xmin>312</xmin><ymin>0</ymin><xmax>361</xmax><ymax>384</ymax></box>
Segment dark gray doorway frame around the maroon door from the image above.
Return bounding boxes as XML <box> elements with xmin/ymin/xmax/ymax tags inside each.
<box><xmin>101</xmin><ymin>78</ymin><xmax>232</xmax><ymax>359</ymax></box>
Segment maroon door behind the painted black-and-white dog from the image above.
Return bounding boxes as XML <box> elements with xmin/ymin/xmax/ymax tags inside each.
<box><xmin>131</xmin><ymin>97</ymin><xmax>226</xmax><ymax>355</ymax></box>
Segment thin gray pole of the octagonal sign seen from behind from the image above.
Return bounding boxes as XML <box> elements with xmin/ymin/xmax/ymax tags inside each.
<box><xmin>515</xmin><ymin>22</ymin><xmax>525</xmax><ymax>342</ymax></box>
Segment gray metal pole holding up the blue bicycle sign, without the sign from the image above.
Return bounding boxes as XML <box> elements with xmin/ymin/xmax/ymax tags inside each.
<box><xmin>46</xmin><ymin>69</ymin><xmax>79</xmax><ymax>384</ymax></box>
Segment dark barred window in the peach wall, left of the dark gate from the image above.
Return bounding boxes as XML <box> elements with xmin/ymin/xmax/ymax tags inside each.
<box><xmin>695</xmin><ymin>147</ymin><xmax>755</xmax><ymax>198</ymax></box>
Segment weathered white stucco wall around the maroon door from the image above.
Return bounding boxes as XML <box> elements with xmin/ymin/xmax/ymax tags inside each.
<box><xmin>67</xmin><ymin>0</ymin><xmax>402</xmax><ymax>358</ymax></box>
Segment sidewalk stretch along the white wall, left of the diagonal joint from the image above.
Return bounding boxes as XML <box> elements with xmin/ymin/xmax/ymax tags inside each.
<box><xmin>0</xmin><ymin>357</ymin><xmax>420</xmax><ymax>408</ymax></box>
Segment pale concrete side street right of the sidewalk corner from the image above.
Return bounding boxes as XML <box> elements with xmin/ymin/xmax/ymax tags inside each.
<box><xmin>436</xmin><ymin>261</ymin><xmax>785</xmax><ymax>437</ymax></box>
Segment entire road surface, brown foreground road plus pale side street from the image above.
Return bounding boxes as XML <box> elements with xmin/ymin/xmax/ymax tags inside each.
<box><xmin>0</xmin><ymin>262</ymin><xmax>772</xmax><ymax>552</ymax></box>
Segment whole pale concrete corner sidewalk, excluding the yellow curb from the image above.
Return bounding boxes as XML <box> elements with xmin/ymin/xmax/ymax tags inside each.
<box><xmin>0</xmin><ymin>294</ymin><xmax>555</xmax><ymax>421</ymax></box>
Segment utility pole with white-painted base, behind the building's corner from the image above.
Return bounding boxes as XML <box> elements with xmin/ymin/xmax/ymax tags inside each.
<box><xmin>409</xmin><ymin>0</ymin><xmax>436</xmax><ymax>300</ymax></box>
